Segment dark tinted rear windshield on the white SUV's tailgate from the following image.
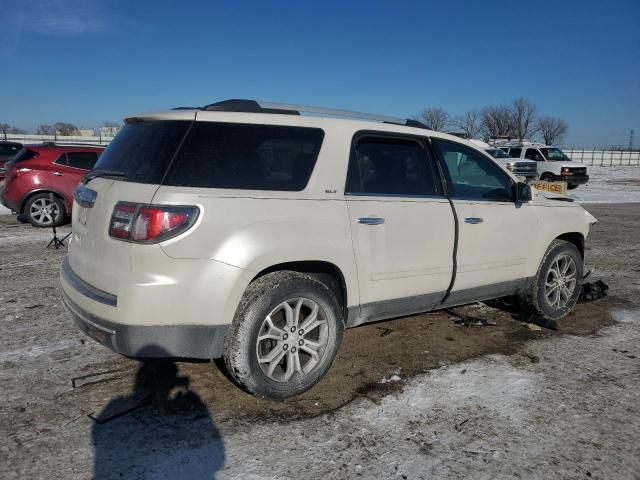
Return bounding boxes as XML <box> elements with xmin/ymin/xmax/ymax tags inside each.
<box><xmin>95</xmin><ymin>120</ymin><xmax>191</xmax><ymax>183</ymax></box>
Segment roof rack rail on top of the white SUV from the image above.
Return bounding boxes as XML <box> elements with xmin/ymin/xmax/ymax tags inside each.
<box><xmin>200</xmin><ymin>99</ymin><xmax>429</xmax><ymax>129</ymax></box>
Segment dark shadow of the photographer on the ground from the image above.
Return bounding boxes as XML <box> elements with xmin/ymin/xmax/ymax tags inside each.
<box><xmin>91</xmin><ymin>346</ymin><xmax>225</xmax><ymax>480</ymax></box>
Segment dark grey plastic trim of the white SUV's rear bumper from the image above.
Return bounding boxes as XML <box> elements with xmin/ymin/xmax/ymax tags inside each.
<box><xmin>60</xmin><ymin>258</ymin><xmax>229</xmax><ymax>359</ymax></box>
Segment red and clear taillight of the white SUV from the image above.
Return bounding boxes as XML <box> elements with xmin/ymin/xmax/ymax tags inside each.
<box><xmin>109</xmin><ymin>202</ymin><xmax>200</xmax><ymax>243</ymax></box>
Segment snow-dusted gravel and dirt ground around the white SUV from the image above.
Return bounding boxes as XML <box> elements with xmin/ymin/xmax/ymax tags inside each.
<box><xmin>0</xmin><ymin>205</ymin><xmax>640</xmax><ymax>479</ymax></box>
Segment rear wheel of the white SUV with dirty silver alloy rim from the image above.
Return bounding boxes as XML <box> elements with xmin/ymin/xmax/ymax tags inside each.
<box><xmin>224</xmin><ymin>271</ymin><xmax>344</xmax><ymax>400</ymax></box>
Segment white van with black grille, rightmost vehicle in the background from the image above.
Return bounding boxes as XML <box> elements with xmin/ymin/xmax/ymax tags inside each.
<box><xmin>500</xmin><ymin>143</ymin><xmax>589</xmax><ymax>190</ymax></box>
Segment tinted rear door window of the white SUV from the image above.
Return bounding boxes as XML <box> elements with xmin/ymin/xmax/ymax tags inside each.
<box><xmin>345</xmin><ymin>136</ymin><xmax>440</xmax><ymax>196</ymax></box>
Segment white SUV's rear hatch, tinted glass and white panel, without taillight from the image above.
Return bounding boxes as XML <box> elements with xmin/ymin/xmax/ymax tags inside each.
<box><xmin>69</xmin><ymin>115</ymin><xmax>195</xmax><ymax>295</ymax></box>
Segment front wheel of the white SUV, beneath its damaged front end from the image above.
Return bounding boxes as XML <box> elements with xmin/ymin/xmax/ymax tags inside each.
<box><xmin>520</xmin><ymin>240</ymin><xmax>583</xmax><ymax>321</ymax></box>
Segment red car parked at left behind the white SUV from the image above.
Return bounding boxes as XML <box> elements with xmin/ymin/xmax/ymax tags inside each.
<box><xmin>0</xmin><ymin>143</ymin><xmax>104</xmax><ymax>227</ymax></box>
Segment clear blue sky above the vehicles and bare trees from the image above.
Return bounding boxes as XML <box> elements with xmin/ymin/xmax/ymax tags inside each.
<box><xmin>0</xmin><ymin>0</ymin><xmax>640</xmax><ymax>146</ymax></box>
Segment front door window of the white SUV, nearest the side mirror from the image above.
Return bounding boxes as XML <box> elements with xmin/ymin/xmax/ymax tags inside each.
<box><xmin>434</xmin><ymin>139</ymin><xmax>513</xmax><ymax>202</ymax></box>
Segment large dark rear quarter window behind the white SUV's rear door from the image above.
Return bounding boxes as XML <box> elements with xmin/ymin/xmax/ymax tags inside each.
<box><xmin>164</xmin><ymin>122</ymin><xmax>324</xmax><ymax>191</ymax></box>
